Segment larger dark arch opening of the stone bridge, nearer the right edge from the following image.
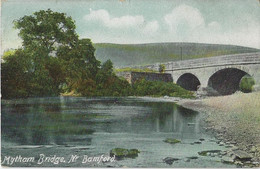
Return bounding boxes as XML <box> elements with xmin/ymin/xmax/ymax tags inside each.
<box><xmin>208</xmin><ymin>68</ymin><xmax>250</xmax><ymax>95</ymax></box>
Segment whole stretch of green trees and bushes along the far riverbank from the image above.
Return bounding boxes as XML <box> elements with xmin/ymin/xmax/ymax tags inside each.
<box><xmin>1</xmin><ymin>9</ymin><xmax>192</xmax><ymax>98</ymax></box>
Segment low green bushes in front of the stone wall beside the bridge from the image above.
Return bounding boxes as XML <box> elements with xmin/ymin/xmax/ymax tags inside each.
<box><xmin>133</xmin><ymin>79</ymin><xmax>194</xmax><ymax>98</ymax></box>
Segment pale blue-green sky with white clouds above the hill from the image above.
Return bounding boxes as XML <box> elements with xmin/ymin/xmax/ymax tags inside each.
<box><xmin>1</xmin><ymin>0</ymin><xmax>260</xmax><ymax>51</ymax></box>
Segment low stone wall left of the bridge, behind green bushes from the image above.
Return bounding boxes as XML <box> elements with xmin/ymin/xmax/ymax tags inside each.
<box><xmin>117</xmin><ymin>72</ymin><xmax>173</xmax><ymax>84</ymax></box>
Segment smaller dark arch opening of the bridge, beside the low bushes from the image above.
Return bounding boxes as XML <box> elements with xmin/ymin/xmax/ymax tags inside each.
<box><xmin>177</xmin><ymin>73</ymin><xmax>200</xmax><ymax>91</ymax></box>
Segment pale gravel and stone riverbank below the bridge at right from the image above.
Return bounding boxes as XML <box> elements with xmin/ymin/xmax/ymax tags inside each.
<box><xmin>177</xmin><ymin>92</ymin><xmax>260</xmax><ymax>167</ymax></box>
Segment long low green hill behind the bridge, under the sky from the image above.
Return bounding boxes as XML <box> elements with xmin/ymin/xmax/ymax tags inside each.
<box><xmin>94</xmin><ymin>43</ymin><xmax>260</xmax><ymax>67</ymax></box>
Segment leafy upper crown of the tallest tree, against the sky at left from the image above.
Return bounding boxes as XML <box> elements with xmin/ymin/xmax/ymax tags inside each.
<box><xmin>14</xmin><ymin>9</ymin><xmax>78</xmax><ymax>55</ymax></box>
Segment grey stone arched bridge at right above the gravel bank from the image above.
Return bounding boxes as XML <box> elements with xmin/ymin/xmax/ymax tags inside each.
<box><xmin>136</xmin><ymin>52</ymin><xmax>260</xmax><ymax>95</ymax></box>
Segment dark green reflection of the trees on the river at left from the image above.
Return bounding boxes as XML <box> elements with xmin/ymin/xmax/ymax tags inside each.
<box><xmin>1</xmin><ymin>98</ymin><xmax>94</xmax><ymax>145</ymax></box>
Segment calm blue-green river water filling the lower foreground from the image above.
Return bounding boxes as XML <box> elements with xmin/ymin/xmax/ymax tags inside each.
<box><xmin>1</xmin><ymin>97</ymin><xmax>234</xmax><ymax>167</ymax></box>
